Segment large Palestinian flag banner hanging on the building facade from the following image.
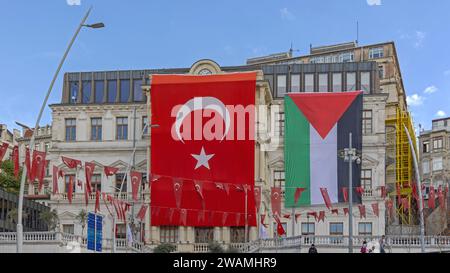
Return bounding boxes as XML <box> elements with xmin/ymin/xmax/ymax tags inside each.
<box><xmin>284</xmin><ymin>91</ymin><xmax>363</xmax><ymax>207</ymax></box>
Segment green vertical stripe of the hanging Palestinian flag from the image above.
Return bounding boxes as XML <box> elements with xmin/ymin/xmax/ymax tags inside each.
<box><xmin>284</xmin><ymin>97</ymin><xmax>311</xmax><ymax>204</ymax></box>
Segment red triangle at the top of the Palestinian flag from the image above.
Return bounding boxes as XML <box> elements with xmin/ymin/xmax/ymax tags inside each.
<box><xmin>288</xmin><ymin>92</ymin><xmax>361</xmax><ymax>138</ymax></box>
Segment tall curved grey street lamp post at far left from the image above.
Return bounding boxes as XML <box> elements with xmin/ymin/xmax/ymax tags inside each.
<box><xmin>16</xmin><ymin>6</ymin><xmax>105</xmax><ymax>253</ymax></box>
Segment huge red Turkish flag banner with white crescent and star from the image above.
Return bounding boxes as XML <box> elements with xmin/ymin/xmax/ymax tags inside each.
<box><xmin>151</xmin><ymin>72</ymin><xmax>256</xmax><ymax>226</ymax></box>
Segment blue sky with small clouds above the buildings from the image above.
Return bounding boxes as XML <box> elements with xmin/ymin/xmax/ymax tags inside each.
<box><xmin>0</xmin><ymin>0</ymin><xmax>450</xmax><ymax>132</ymax></box>
